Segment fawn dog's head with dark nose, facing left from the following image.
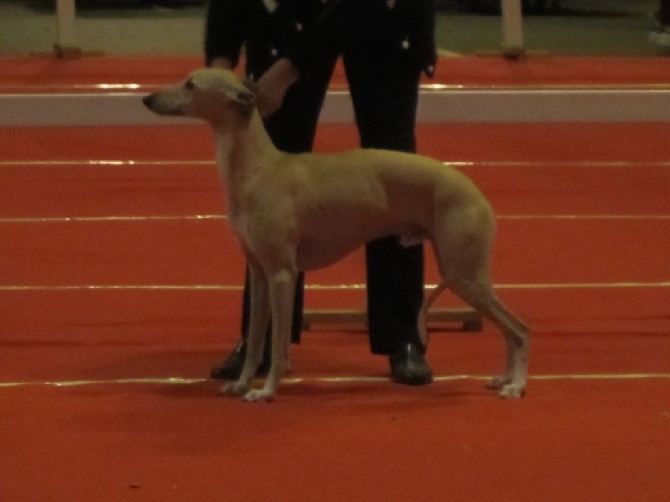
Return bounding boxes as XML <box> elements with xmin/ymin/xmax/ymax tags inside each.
<box><xmin>142</xmin><ymin>68</ymin><xmax>256</xmax><ymax>125</ymax></box>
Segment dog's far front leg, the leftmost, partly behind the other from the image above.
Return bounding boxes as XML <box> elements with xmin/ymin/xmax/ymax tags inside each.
<box><xmin>222</xmin><ymin>263</ymin><xmax>270</xmax><ymax>396</ymax></box>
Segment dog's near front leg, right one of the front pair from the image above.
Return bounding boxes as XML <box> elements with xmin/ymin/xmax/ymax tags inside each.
<box><xmin>244</xmin><ymin>270</ymin><xmax>297</xmax><ymax>401</ymax></box>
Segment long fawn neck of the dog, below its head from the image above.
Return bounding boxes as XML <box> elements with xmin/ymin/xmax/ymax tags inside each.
<box><xmin>214</xmin><ymin>110</ymin><xmax>281</xmax><ymax>215</ymax></box>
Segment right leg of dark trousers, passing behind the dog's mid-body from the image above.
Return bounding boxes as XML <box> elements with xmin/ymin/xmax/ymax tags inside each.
<box><xmin>344</xmin><ymin>30</ymin><xmax>424</xmax><ymax>354</ymax></box>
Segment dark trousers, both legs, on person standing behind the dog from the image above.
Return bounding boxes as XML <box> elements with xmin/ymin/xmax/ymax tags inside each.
<box><xmin>242</xmin><ymin>23</ymin><xmax>423</xmax><ymax>354</ymax></box>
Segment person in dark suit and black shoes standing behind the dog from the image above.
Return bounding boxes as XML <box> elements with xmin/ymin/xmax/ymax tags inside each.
<box><xmin>205</xmin><ymin>0</ymin><xmax>436</xmax><ymax>385</ymax></box>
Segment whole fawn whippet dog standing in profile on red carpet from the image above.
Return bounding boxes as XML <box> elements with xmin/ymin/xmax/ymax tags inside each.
<box><xmin>144</xmin><ymin>69</ymin><xmax>529</xmax><ymax>401</ymax></box>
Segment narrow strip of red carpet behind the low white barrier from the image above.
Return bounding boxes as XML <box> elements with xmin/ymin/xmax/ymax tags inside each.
<box><xmin>0</xmin><ymin>57</ymin><xmax>670</xmax><ymax>86</ymax></box>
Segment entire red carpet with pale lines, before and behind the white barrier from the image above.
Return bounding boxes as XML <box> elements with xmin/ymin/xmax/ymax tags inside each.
<box><xmin>0</xmin><ymin>58</ymin><xmax>670</xmax><ymax>502</ymax></box>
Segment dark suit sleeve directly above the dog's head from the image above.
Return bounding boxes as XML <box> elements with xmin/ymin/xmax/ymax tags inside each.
<box><xmin>205</xmin><ymin>0</ymin><xmax>252</xmax><ymax>66</ymax></box>
